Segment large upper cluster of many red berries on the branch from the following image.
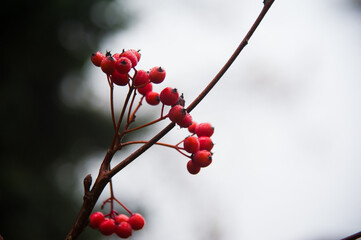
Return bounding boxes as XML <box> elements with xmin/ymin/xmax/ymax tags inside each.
<box><xmin>91</xmin><ymin>49</ymin><xmax>214</xmax><ymax>174</ymax></box>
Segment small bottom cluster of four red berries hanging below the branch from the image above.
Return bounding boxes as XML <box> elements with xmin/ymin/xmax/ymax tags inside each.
<box><xmin>89</xmin><ymin>212</ymin><xmax>145</xmax><ymax>238</ymax></box>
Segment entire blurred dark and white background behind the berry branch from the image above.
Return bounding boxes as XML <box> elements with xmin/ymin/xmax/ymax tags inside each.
<box><xmin>0</xmin><ymin>0</ymin><xmax>361</xmax><ymax>240</ymax></box>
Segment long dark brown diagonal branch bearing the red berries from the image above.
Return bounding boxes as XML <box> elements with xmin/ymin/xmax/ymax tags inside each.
<box><xmin>65</xmin><ymin>0</ymin><xmax>274</xmax><ymax>240</ymax></box>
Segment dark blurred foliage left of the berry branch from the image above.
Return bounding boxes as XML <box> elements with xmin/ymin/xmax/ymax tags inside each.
<box><xmin>0</xmin><ymin>0</ymin><xmax>126</xmax><ymax>240</ymax></box>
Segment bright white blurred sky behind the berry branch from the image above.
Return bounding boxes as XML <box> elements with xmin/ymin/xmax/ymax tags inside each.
<box><xmin>70</xmin><ymin>0</ymin><xmax>361</xmax><ymax>240</ymax></box>
